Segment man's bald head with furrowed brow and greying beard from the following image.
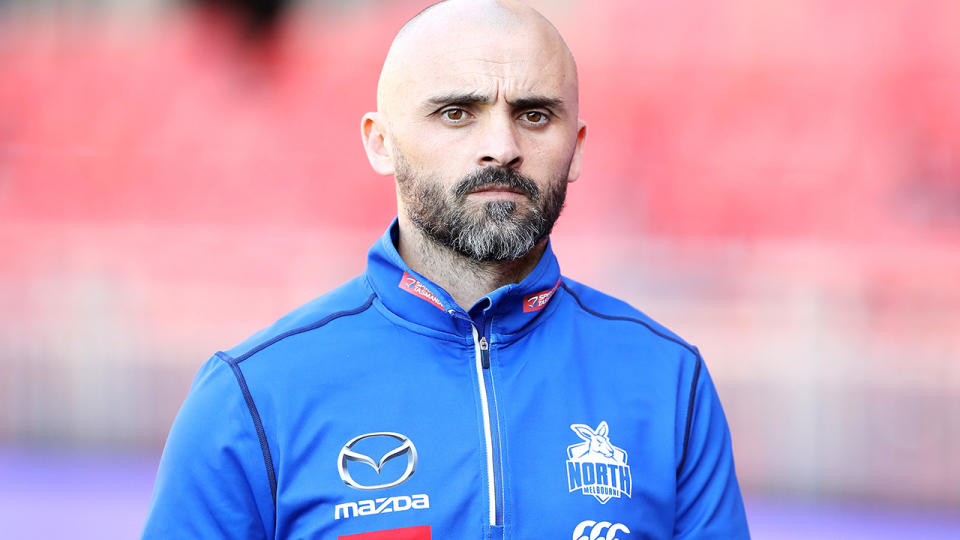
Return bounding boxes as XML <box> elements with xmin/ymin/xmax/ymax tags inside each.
<box><xmin>362</xmin><ymin>0</ymin><xmax>586</xmax><ymax>261</ymax></box>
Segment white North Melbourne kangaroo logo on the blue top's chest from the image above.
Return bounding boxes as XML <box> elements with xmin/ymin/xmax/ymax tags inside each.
<box><xmin>567</xmin><ymin>422</ymin><xmax>633</xmax><ymax>504</ymax></box>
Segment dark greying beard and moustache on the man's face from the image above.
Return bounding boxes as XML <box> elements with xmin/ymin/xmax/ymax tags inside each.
<box><xmin>395</xmin><ymin>156</ymin><xmax>569</xmax><ymax>262</ymax></box>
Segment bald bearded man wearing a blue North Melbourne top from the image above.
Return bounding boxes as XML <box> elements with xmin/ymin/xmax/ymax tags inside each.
<box><xmin>144</xmin><ymin>0</ymin><xmax>749</xmax><ymax>540</ymax></box>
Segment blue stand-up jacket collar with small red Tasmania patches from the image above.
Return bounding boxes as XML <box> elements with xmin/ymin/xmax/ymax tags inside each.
<box><xmin>365</xmin><ymin>219</ymin><xmax>560</xmax><ymax>336</ymax></box>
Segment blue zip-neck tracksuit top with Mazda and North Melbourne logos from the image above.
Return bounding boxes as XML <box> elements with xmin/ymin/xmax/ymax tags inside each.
<box><xmin>143</xmin><ymin>220</ymin><xmax>749</xmax><ymax>540</ymax></box>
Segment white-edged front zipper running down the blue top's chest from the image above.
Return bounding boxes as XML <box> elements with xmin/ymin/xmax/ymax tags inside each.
<box><xmin>448</xmin><ymin>309</ymin><xmax>503</xmax><ymax>527</ymax></box>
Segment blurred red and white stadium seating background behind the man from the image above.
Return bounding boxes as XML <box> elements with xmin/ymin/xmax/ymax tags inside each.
<box><xmin>0</xmin><ymin>0</ymin><xmax>960</xmax><ymax>539</ymax></box>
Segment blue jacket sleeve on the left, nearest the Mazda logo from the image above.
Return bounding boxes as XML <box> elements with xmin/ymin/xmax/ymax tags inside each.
<box><xmin>142</xmin><ymin>356</ymin><xmax>273</xmax><ymax>539</ymax></box>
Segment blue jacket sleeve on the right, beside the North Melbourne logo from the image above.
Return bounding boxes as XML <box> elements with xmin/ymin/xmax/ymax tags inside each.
<box><xmin>674</xmin><ymin>355</ymin><xmax>750</xmax><ymax>540</ymax></box>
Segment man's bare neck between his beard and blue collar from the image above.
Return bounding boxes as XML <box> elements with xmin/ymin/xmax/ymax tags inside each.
<box><xmin>397</xmin><ymin>220</ymin><xmax>547</xmax><ymax>310</ymax></box>
